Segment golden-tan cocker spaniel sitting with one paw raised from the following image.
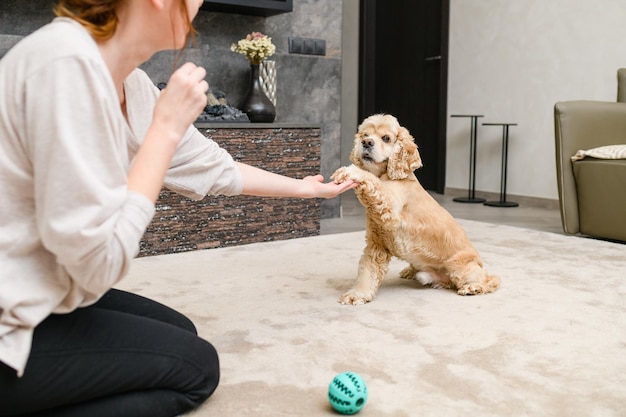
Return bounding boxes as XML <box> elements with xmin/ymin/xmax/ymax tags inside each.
<box><xmin>332</xmin><ymin>114</ymin><xmax>500</xmax><ymax>305</ymax></box>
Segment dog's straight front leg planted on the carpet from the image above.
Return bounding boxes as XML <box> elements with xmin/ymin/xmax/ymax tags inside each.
<box><xmin>339</xmin><ymin>244</ymin><xmax>391</xmax><ymax>305</ymax></box>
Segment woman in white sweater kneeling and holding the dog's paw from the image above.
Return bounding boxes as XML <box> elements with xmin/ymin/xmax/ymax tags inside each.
<box><xmin>0</xmin><ymin>0</ymin><xmax>354</xmax><ymax>417</ymax></box>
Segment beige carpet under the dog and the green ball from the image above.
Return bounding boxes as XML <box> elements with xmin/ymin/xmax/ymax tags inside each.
<box><xmin>120</xmin><ymin>220</ymin><xmax>626</xmax><ymax>417</ymax></box>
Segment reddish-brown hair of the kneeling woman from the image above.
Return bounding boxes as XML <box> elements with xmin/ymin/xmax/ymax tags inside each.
<box><xmin>54</xmin><ymin>0</ymin><xmax>196</xmax><ymax>43</ymax></box>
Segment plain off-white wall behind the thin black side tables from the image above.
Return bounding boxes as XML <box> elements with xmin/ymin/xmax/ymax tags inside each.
<box><xmin>446</xmin><ymin>0</ymin><xmax>626</xmax><ymax>199</ymax></box>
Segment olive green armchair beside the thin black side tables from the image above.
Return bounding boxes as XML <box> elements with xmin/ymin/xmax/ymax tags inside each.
<box><xmin>554</xmin><ymin>69</ymin><xmax>626</xmax><ymax>242</ymax></box>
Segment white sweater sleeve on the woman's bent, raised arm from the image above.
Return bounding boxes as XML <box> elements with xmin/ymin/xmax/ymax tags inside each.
<box><xmin>23</xmin><ymin>56</ymin><xmax>154</xmax><ymax>294</ymax></box>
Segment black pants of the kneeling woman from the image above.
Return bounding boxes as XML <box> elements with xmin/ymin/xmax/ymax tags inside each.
<box><xmin>0</xmin><ymin>290</ymin><xmax>219</xmax><ymax>417</ymax></box>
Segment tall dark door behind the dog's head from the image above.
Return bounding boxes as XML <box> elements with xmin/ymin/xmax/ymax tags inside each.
<box><xmin>359</xmin><ymin>0</ymin><xmax>449</xmax><ymax>193</ymax></box>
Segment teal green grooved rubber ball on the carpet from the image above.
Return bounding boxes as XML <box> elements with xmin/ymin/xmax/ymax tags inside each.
<box><xmin>328</xmin><ymin>372</ymin><xmax>367</xmax><ymax>414</ymax></box>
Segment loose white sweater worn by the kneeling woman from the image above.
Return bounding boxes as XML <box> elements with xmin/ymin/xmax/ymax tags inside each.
<box><xmin>0</xmin><ymin>18</ymin><xmax>242</xmax><ymax>375</ymax></box>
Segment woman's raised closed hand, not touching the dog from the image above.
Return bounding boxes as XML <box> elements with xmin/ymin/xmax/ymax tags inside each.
<box><xmin>153</xmin><ymin>62</ymin><xmax>209</xmax><ymax>140</ymax></box>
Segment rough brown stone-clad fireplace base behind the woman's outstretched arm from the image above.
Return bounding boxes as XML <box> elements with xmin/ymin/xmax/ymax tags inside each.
<box><xmin>139</xmin><ymin>123</ymin><xmax>321</xmax><ymax>256</ymax></box>
